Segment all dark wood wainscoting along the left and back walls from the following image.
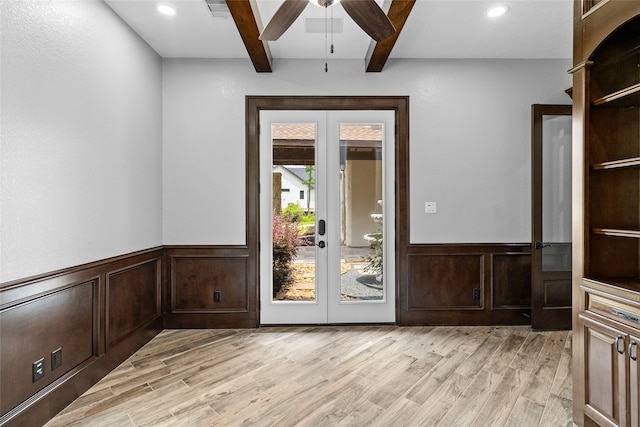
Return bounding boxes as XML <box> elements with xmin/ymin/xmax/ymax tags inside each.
<box><xmin>0</xmin><ymin>244</ymin><xmax>531</xmax><ymax>427</ymax></box>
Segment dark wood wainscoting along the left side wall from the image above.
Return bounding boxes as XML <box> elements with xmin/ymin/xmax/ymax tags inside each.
<box><xmin>0</xmin><ymin>248</ymin><xmax>162</xmax><ymax>426</ymax></box>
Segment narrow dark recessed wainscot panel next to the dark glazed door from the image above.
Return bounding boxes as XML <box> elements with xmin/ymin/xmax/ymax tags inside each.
<box><xmin>491</xmin><ymin>253</ymin><xmax>531</xmax><ymax>309</ymax></box>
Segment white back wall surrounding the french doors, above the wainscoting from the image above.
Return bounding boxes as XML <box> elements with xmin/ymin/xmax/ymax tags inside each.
<box><xmin>163</xmin><ymin>59</ymin><xmax>571</xmax><ymax>244</ymax></box>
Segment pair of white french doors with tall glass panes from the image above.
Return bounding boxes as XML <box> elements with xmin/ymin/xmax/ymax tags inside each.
<box><xmin>260</xmin><ymin>111</ymin><xmax>395</xmax><ymax>324</ymax></box>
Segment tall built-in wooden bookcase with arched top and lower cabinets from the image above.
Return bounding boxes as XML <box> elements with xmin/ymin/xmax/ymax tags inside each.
<box><xmin>571</xmin><ymin>0</ymin><xmax>640</xmax><ymax>426</ymax></box>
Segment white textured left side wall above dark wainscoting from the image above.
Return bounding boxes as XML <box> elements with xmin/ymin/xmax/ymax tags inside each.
<box><xmin>0</xmin><ymin>0</ymin><xmax>162</xmax><ymax>282</ymax></box>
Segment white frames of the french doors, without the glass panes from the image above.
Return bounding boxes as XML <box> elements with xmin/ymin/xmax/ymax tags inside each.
<box><xmin>259</xmin><ymin>110</ymin><xmax>397</xmax><ymax>324</ymax></box>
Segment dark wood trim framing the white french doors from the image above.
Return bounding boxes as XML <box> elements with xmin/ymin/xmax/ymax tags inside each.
<box><xmin>246</xmin><ymin>96</ymin><xmax>409</xmax><ymax>326</ymax></box>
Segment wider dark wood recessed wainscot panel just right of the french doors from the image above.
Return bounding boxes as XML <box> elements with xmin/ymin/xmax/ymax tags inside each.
<box><xmin>407</xmin><ymin>254</ymin><xmax>484</xmax><ymax>310</ymax></box>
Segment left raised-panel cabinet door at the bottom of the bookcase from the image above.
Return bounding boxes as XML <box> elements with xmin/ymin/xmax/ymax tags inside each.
<box><xmin>580</xmin><ymin>316</ymin><xmax>628</xmax><ymax>426</ymax></box>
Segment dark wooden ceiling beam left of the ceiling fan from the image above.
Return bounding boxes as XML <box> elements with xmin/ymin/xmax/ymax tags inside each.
<box><xmin>226</xmin><ymin>0</ymin><xmax>272</xmax><ymax>73</ymax></box>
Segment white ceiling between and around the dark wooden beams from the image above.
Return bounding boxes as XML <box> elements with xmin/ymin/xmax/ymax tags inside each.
<box><xmin>105</xmin><ymin>0</ymin><xmax>573</xmax><ymax>59</ymax></box>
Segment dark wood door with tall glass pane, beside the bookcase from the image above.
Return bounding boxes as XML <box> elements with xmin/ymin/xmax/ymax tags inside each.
<box><xmin>531</xmin><ymin>104</ymin><xmax>571</xmax><ymax>329</ymax></box>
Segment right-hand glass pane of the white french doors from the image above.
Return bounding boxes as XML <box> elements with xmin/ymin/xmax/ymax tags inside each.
<box><xmin>339</xmin><ymin>123</ymin><xmax>384</xmax><ymax>302</ymax></box>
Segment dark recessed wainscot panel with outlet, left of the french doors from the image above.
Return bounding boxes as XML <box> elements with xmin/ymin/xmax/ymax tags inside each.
<box><xmin>171</xmin><ymin>256</ymin><xmax>249</xmax><ymax>313</ymax></box>
